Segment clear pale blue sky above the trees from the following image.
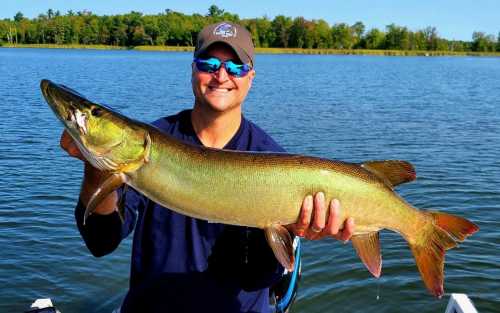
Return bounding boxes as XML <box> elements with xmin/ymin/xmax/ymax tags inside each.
<box><xmin>0</xmin><ymin>0</ymin><xmax>500</xmax><ymax>40</ymax></box>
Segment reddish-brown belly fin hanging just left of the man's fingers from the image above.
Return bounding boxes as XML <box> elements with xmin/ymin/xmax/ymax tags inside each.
<box><xmin>264</xmin><ymin>224</ymin><xmax>295</xmax><ymax>272</ymax></box>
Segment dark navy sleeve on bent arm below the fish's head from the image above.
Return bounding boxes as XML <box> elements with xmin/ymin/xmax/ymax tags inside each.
<box><xmin>75</xmin><ymin>188</ymin><xmax>147</xmax><ymax>257</ymax></box>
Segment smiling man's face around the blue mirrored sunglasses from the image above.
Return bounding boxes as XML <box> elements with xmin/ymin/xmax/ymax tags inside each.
<box><xmin>191</xmin><ymin>44</ymin><xmax>255</xmax><ymax>112</ymax></box>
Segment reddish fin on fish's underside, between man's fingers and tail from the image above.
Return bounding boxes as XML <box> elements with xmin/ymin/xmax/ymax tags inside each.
<box><xmin>351</xmin><ymin>231</ymin><xmax>382</xmax><ymax>278</ymax></box>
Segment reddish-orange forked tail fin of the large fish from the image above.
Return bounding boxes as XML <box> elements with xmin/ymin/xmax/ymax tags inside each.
<box><xmin>409</xmin><ymin>212</ymin><xmax>479</xmax><ymax>298</ymax></box>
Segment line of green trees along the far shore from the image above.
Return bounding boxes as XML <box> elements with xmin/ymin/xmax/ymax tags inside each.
<box><xmin>0</xmin><ymin>5</ymin><xmax>500</xmax><ymax>52</ymax></box>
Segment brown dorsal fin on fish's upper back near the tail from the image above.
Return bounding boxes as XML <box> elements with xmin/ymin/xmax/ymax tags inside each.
<box><xmin>361</xmin><ymin>160</ymin><xmax>417</xmax><ymax>187</ymax></box>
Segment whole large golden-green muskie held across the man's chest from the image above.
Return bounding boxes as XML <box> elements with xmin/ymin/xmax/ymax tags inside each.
<box><xmin>41</xmin><ymin>80</ymin><xmax>479</xmax><ymax>297</ymax></box>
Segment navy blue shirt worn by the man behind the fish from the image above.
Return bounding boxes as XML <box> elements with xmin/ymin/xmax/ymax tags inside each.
<box><xmin>75</xmin><ymin>110</ymin><xmax>284</xmax><ymax>313</ymax></box>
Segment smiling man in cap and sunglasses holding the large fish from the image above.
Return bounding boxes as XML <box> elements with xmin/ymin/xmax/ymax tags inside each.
<box><xmin>61</xmin><ymin>22</ymin><xmax>354</xmax><ymax>313</ymax></box>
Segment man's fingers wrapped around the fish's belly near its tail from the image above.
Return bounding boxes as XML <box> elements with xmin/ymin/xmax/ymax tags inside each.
<box><xmin>287</xmin><ymin>192</ymin><xmax>354</xmax><ymax>242</ymax></box>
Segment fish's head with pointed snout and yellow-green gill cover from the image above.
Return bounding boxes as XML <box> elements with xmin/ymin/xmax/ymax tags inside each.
<box><xmin>40</xmin><ymin>80</ymin><xmax>150</xmax><ymax>172</ymax></box>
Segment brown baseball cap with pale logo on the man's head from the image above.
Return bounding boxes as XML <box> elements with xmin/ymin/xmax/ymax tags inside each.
<box><xmin>194</xmin><ymin>22</ymin><xmax>254</xmax><ymax>66</ymax></box>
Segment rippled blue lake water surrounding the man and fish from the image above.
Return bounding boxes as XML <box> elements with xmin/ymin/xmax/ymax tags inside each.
<box><xmin>0</xmin><ymin>49</ymin><xmax>500</xmax><ymax>313</ymax></box>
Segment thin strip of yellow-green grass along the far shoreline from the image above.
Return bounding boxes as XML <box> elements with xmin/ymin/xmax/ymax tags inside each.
<box><xmin>3</xmin><ymin>43</ymin><xmax>500</xmax><ymax>57</ymax></box>
